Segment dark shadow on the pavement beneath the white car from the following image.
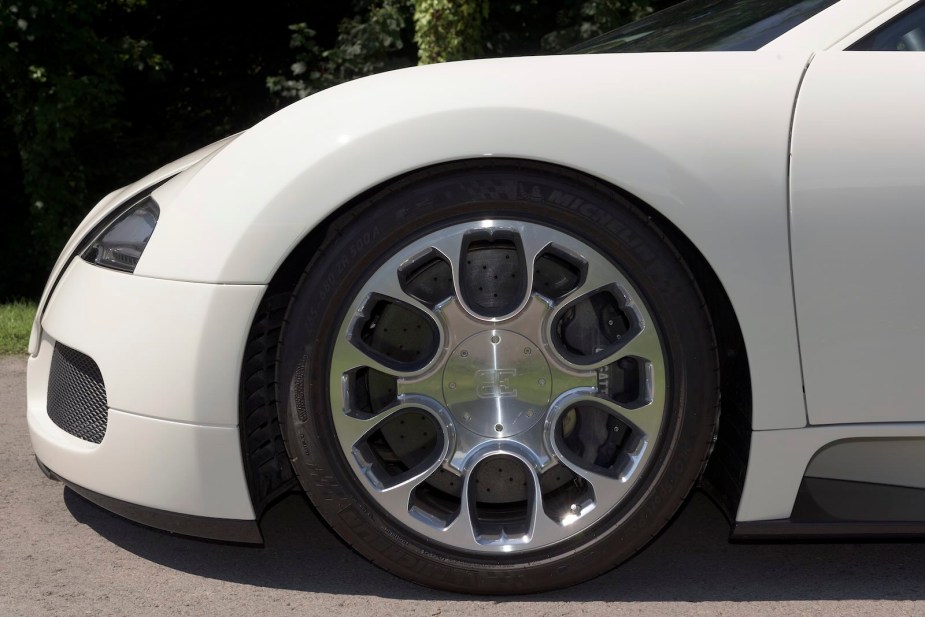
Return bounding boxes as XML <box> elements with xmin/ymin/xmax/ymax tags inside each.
<box><xmin>64</xmin><ymin>489</ymin><xmax>925</xmax><ymax>602</ymax></box>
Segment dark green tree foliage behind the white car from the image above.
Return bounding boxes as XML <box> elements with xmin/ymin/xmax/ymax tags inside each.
<box><xmin>0</xmin><ymin>0</ymin><xmax>678</xmax><ymax>302</ymax></box>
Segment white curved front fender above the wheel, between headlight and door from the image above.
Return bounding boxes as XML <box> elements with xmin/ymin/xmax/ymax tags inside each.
<box><xmin>136</xmin><ymin>52</ymin><xmax>806</xmax><ymax>429</ymax></box>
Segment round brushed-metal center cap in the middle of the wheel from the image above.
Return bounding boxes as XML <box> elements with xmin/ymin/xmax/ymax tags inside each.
<box><xmin>443</xmin><ymin>330</ymin><xmax>552</xmax><ymax>437</ymax></box>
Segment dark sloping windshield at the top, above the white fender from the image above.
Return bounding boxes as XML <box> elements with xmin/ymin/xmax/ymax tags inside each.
<box><xmin>565</xmin><ymin>0</ymin><xmax>838</xmax><ymax>54</ymax></box>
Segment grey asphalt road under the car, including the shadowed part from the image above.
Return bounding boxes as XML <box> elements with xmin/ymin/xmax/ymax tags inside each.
<box><xmin>0</xmin><ymin>357</ymin><xmax>925</xmax><ymax>617</ymax></box>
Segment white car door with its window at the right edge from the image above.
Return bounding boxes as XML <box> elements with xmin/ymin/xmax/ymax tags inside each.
<box><xmin>791</xmin><ymin>2</ymin><xmax>925</xmax><ymax>424</ymax></box>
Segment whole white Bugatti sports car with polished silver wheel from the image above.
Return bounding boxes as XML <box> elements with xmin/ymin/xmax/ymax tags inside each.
<box><xmin>28</xmin><ymin>0</ymin><xmax>925</xmax><ymax>593</ymax></box>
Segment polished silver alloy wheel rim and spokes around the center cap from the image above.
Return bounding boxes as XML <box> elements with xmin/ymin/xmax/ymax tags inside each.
<box><xmin>329</xmin><ymin>219</ymin><xmax>667</xmax><ymax>553</ymax></box>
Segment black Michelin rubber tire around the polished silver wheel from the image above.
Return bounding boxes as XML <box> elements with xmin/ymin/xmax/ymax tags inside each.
<box><xmin>279</xmin><ymin>161</ymin><xmax>719</xmax><ymax>594</ymax></box>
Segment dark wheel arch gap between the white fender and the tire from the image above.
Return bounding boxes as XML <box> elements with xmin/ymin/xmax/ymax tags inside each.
<box><xmin>240</xmin><ymin>158</ymin><xmax>752</xmax><ymax>521</ymax></box>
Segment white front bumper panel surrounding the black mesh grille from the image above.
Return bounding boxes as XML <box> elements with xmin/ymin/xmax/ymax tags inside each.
<box><xmin>27</xmin><ymin>258</ymin><xmax>265</xmax><ymax>533</ymax></box>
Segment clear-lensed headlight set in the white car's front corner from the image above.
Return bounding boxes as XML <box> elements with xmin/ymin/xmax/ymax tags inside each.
<box><xmin>80</xmin><ymin>197</ymin><xmax>161</xmax><ymax>272</ymax></box>
